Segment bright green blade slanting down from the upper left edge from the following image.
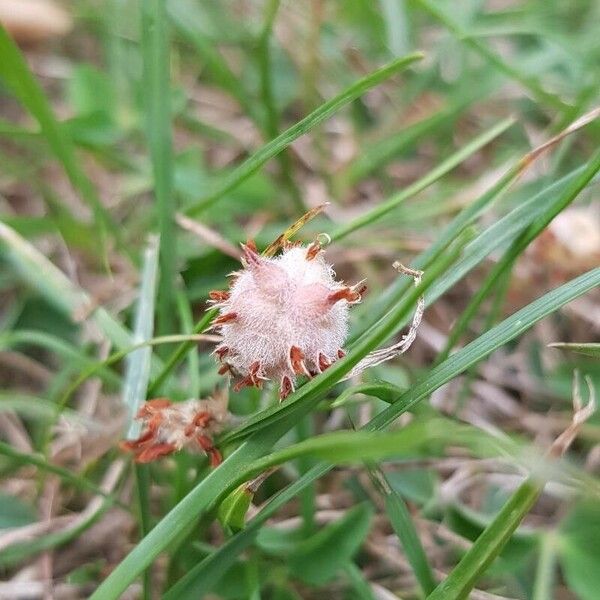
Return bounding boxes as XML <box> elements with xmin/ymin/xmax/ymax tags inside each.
<box><xmin>0</xmin><ymin>25</ymin><xmax>120</xmax><ymax>262</ymax></box>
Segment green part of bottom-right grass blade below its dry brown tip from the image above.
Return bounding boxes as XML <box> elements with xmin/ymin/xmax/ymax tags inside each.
<box><xmin>427</xmin><ymin>479</ymin><xmax>544</xmax><ymax>600</ymax></box>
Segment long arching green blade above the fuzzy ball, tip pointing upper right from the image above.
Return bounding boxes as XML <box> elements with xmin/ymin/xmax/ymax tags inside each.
<box><xmin>186</xmin><ymin>53</ymin><xmax>423</xmax><ymax>215</ymax></box>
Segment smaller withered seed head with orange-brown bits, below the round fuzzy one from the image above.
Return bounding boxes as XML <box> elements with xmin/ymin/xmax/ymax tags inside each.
<box><xmin>121</xmin><ymin>398</ymin><xmax>228</xmax><ymax>467</ymax></box>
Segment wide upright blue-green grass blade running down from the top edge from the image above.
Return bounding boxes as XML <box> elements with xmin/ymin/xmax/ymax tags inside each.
<box><xmin>141</xmin><ymin>0</ymin><xmax>177</xmax><ymax>335</ymax></box>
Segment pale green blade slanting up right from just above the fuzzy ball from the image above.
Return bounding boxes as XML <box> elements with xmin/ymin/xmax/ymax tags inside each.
<box><xmin>331</xmin><ymin>118</ymin><xmax>515</xmax><ymax>241</ymax></box>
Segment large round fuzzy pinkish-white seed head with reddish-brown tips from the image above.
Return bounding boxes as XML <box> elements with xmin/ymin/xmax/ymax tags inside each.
<box><xmin>211</xmin><ymin>242</ymin><xmax>366</xmax><ymax>399</ymax></box>
